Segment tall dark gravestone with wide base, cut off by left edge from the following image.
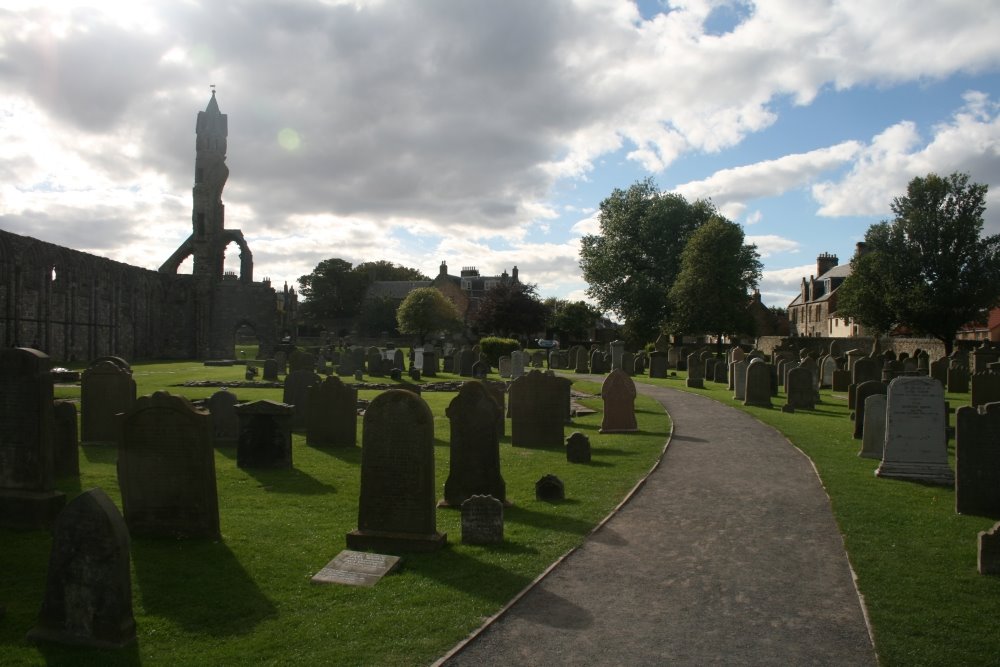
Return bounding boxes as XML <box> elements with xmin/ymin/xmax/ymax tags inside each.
<box><xmin>0</xmin><ymin>348</ymin><xmax>66</xmax><ymax>528</ymax></box>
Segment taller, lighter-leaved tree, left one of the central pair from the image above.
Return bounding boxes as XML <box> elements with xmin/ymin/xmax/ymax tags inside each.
<box><xmin>580</xmin><ymin>178</ymin><xmax>716</xmax><ymax>344</ymax></box>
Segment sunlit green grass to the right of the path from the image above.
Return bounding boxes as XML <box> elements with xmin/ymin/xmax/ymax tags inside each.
<box><xmin>644</xmin><ymin>373</ymin><xmax>1000</xmax><ymax>665</ymax></box>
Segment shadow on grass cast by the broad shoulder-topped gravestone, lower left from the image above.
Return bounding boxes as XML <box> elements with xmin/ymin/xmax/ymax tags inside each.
<box><xmin>132</xmin><ymin>538</ymin><xmax>277</xmax><ymax>637</ymax></box>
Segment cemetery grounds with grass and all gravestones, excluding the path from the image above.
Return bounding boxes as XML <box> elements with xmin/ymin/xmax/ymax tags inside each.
<box><xmin>0</xmin><ymin>344</ymin><xmax>1000</xmax><ymax>664</ymax></box>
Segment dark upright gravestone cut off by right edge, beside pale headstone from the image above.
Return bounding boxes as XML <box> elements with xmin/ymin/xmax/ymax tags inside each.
<box><xmin>955</xmin><ymin>403</ymin><xmax>1000</xmax><ymax>517</ymax></box>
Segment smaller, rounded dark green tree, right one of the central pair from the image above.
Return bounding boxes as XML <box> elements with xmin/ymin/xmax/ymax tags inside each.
<box><xmin>667</xmin><ymin>217</ymin><xmax>763</xmax><ymax>353</ymax></box>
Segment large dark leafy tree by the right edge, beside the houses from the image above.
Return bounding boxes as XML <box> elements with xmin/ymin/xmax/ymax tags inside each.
<box><xmin>837</xmin><ymin>173</ymin><xmax>1000</xmax><ymax>354</ymax></box>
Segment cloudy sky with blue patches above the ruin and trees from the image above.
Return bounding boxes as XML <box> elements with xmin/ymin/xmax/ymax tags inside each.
<box><xmin>0</xmin><ymin>0</ymin><xmax>1000</xmax><ymax>314</ymax></box>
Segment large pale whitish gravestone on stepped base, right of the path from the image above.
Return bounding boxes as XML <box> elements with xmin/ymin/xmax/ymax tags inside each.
<box><xmin>875</xmin><ymin>376</ymin><xmax>955</xmax><ymax>486</ymax></box>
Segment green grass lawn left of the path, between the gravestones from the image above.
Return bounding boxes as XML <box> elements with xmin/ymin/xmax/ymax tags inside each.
<box><xmin>0</xmin><ymin>362</ymin><xmax>669</xmax><ymax>665</ymax></box>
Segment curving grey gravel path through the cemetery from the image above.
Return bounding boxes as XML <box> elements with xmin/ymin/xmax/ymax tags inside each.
<box><xmin>437</xmin><ymin>384</ymin><xmax>877</xmax><ymax>667</ymax></box>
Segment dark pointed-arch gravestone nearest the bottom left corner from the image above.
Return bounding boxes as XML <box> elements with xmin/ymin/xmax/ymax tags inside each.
<box><xmin>28</xmin><ymin>489</ymin><xmax>135</xmax><ymax>648</ymax></box>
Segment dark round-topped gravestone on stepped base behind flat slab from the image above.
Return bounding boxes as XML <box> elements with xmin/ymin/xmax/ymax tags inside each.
<box><xmin>347</xmin><ymin>389</ymin><xmax>447</xmax><ymax>553</ymax></box>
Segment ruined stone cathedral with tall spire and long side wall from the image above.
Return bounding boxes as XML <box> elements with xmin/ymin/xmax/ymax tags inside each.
<box><xmin>0</xmin><ymin>91</ymin><xmax>297</xmax><ymax>363</ymax></box>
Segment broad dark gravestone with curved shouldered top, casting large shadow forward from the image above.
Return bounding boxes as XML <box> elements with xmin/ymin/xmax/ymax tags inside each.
<box><xmin>118</xmin><ymin>391</ymin><xmax>219</xmax><ymax>539</ymax></box>
